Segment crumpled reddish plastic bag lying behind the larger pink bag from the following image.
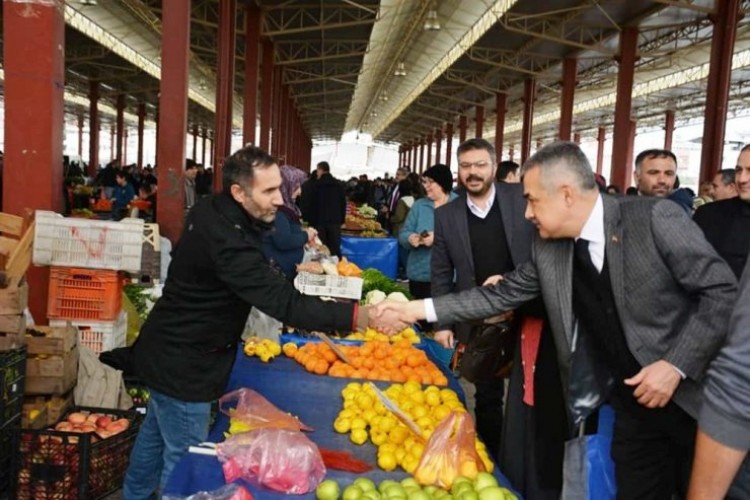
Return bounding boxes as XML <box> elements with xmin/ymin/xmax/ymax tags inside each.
<box><xmin>219</xmin><ymin>388</ymin><xmax>313</xmax><ymax>431</ymax></box>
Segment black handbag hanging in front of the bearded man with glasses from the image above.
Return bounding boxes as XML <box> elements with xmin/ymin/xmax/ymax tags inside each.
<box><xmin>458</xmin><ymin>322</ymin><xmax>518</xmax><ymax>383</ymax></box>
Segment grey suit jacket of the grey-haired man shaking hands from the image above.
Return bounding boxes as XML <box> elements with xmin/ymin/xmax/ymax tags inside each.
<box><xmin>434</xmin><ymin>195</ymin><xmax>737</xmax><ymax>417</ymax></box>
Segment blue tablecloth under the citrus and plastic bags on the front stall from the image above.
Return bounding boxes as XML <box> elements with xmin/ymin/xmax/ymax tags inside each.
<box><xmin>165</xmin><ymin>350</ymin><xmax>524</xmax><ymax>499</ymax></box>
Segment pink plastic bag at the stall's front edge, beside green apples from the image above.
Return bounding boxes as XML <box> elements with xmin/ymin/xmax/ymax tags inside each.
<box><xmin>216</xmin><ymin>429</ymin><xmax>326</xmax><ymax>495</ymax></box>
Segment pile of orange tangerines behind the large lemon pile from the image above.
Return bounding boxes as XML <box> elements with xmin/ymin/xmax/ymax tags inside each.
<box><xmin>289</xmin><ymin>339</ymin><xmax>448</xmax><ymax>385</ymax></box>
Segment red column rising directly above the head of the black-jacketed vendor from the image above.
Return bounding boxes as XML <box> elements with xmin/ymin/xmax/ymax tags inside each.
<box><xmin>213</xmin><ymin>0</ymin><xmax>237</xmax><ymax>191</ymax></box>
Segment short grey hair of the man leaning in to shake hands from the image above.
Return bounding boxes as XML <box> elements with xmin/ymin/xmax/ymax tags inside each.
<box><xmin>521</xmin><ymin>141</ymin><xmax>598</xmax><ymax>191</ymax></box>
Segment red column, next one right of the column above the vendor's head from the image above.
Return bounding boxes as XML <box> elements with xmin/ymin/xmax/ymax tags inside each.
<box><xmin>242</xmin><ymin>2</ymin><xmax>261</xmax><ymax>145</ymax></box>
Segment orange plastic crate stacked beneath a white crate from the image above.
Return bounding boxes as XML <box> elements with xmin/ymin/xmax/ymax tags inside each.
<box><xmin>47</xmin><ymin>267</ymin><xmax>122</xmax><ymax>321</ymax></box>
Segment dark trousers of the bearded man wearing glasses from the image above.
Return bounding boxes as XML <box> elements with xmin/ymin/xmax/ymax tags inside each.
<box><xmin>474</xmin><ymin>378</ymin><xmax>505</xmax><ymax>461</ymax></box>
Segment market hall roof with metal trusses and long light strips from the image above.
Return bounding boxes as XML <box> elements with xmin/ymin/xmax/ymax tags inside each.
<box><xmin>1</xmin><ymin>0</ymin><xmax>750</xmax><ymax>144</ymax></box>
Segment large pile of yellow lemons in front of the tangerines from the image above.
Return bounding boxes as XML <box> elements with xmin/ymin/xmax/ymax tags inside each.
<box><xmin>333</xmin><ymin>381</ymin><xmax>494</xmax><ymax>474</ymax></box>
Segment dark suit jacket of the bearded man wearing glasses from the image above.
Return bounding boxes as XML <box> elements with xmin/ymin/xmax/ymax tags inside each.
<box><xmin>431</xmin><ymin>183</ymin><xmax>534</xmax><ymax>342</ymax></box>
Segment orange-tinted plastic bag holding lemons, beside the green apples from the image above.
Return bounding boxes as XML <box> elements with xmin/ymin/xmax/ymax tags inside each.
<box><xmin>414</xmin><ymin>412</ymin><xmax>485</xmax><ymax>489</ymax></box>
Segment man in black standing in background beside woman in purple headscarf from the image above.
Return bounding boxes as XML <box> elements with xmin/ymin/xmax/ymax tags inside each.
<box><xmin>309</xmin><ymin>161</ymin><xmax>346</xmax><ymax>257</ymax></box>
